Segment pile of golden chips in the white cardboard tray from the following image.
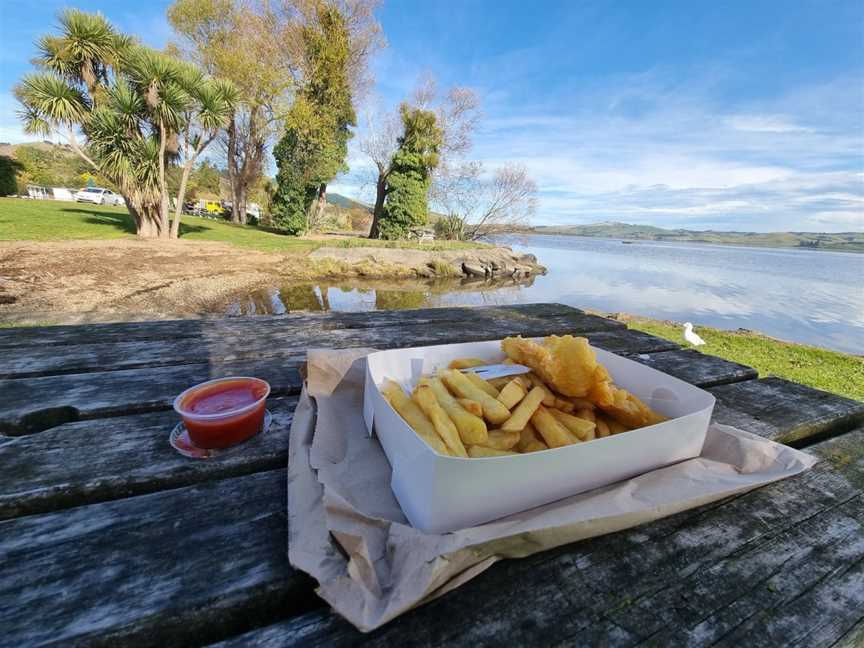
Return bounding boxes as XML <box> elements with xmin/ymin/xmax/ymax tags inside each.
<box><xmin>381</xmin><ymin>358</ymin><xmax>644</xmax><ymax>458</ymax></box>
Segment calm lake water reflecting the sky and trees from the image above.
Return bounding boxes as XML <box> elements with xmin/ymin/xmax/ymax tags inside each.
<box><xmin>229</xmin><ymin>235</ymin><xmax>864</xmax><ymax>354</ymax></box>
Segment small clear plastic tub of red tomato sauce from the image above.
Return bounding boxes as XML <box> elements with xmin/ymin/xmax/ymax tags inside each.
<box><xmin>179</xmin><ymin>378</ymin><xmax>268</xmax><ymax>448</ymax></box>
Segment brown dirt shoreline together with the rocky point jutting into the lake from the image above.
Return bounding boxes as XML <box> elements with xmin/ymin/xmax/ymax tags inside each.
<box><xmin>0</xmin><ymin>240</ymin><xmax>540</xmax><ymax>323</ymax></box>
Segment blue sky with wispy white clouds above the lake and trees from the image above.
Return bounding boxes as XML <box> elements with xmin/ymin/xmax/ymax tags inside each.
<box><xmin>0</xmin><ymin>0</ymin><xmax>864</xmax><ymax>231</ymax></box>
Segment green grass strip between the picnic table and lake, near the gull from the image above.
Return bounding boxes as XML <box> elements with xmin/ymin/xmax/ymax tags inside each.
<box><xmin>627</xmin><ymin>318</ymin><xmax>864</xmax><ymax>401</ymax></box>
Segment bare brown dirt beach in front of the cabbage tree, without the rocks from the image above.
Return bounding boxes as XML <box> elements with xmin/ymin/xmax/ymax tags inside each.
<box><xmin>0</xmin><ymin>240</ymin><xmax>302</xmax><ymax>321</ymax></box>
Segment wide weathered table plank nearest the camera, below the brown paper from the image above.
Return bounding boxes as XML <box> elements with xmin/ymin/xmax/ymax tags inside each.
<box><xmin>208</xmin><ymin>429</ymin><xmax>864</xmax><ymax>647</ymax></box>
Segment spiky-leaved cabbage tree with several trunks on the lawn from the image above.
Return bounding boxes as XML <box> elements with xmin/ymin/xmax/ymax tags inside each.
<box><xmin>15</xmin><ymin>9</ymin><xmax>231</xmax><ymax>238</ymax></box>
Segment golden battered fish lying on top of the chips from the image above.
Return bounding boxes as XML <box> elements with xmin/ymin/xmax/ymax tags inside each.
<box><xmin>501</xmin><ymin>335</ymin><xmax>666</xmax><ymax>428</ymax></box>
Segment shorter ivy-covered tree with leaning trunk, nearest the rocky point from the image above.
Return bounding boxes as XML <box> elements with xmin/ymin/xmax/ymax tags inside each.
<box><xmin>373</xmin><ymin>104</ymin><xmax>443</xmax><ymax>239</ymax></box>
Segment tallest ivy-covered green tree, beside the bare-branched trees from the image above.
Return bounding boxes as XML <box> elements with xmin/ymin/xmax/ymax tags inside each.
<box><xmin>273</xmin><ymin>0</ymin><xmax>356</xmax><ymax>234</ymax></box>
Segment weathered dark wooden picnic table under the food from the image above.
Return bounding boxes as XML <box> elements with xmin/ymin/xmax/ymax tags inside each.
<box><xmin>0</xmin><ymin>304</ymin><xmax>864</xmax><ymax>647</ymax></box>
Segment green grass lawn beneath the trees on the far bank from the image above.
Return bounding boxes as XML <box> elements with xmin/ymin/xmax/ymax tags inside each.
<box><xmin>0</xmin><ymin>198</ymin><xmax>480</xmax><ymax>252</ymax></box>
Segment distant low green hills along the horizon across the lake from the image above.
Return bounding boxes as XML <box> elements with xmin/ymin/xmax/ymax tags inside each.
<box><xmin>530</xmin><ymin>222</ymin><xmax>864</xmax><ymax>252</ymax></box>
